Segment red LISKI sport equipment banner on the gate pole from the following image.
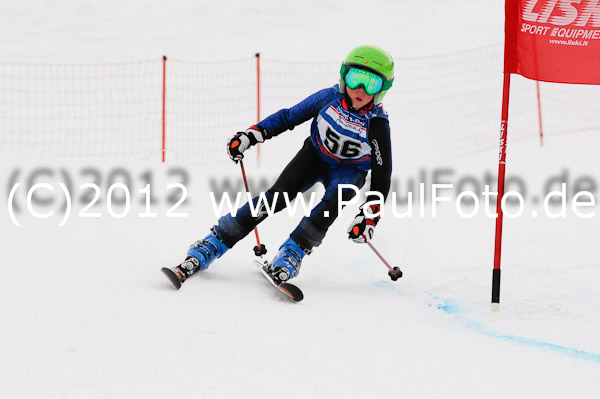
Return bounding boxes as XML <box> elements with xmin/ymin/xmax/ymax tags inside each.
<box><xmin>504</xmin><ymin>0</ymin><xmax>600</xmax><ymax>84</ymax></box>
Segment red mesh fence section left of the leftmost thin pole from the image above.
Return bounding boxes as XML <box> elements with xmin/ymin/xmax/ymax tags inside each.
<box><xmin>0</xmin><ymin>61</ymin><xmax>162</xmax><ymax>160</ymax></box>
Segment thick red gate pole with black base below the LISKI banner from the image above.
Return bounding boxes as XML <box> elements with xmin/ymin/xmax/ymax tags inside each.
<box><xmin>492</xmin><ymin>72</ymin><xmax>510</xmax><ymax>311</ymax></box>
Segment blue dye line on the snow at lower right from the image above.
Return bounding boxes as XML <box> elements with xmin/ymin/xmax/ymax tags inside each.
<box><xmin>430</xmin><ymin>299</ymin><xmax>600</xmax><ymax>363</ymax></box>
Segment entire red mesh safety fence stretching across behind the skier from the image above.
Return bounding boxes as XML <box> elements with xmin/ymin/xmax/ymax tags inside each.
<box><xmin>0</xmin><ymin>44</ymin><xmax>600</xmax><ymax>166</ymax></box>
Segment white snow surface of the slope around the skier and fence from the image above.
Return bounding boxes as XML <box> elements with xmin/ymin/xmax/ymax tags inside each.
<box><xmin>0</xmin><ymin>0</ymin><xmax>600</xmax><ymax>398</ymax></box>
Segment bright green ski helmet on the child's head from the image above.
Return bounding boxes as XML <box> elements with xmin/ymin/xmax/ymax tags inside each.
<box><xmin>340</xmin><ymin>46</ymin><xmax>394</xmax><ymax>104</ymax></box>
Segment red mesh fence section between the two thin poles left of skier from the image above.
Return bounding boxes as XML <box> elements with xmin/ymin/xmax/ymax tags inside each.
<box><xmin>166</xmin><ymin>57</ymin><xmax>257</xmax><ymax>164</ymax></box>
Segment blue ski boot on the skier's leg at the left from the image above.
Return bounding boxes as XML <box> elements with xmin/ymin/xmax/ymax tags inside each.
<box><xmin>162</xmin><ymin>228</ymin><xmax>229</xmax><ymax>289</ymax></box>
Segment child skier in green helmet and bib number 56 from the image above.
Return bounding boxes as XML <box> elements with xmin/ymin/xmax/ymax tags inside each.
<box><xmin>167</xmin><ymin>46</ymin><xmax>394</xmax><ymax>288</ymax></box>
